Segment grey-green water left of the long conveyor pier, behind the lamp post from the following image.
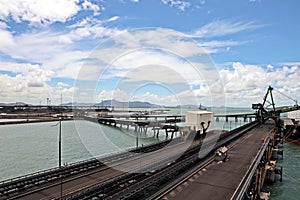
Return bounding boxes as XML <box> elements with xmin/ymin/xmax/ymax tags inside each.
<box><xmin>0</xmin><ymin>120</ymin><xmax>159</xmax><ymax>180</ymax></box>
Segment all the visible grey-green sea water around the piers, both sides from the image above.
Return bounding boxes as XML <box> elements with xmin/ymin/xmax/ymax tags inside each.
<box><xmin>0</xmin><ymin>109</ymin><xmax>300</xmax><ymax>199</ymax></box>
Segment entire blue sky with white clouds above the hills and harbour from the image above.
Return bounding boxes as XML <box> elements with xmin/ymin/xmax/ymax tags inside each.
<box><xmin>0</xmin><ymin>0</ymin><xmax>300</xmax><ymax>107</ymax></box>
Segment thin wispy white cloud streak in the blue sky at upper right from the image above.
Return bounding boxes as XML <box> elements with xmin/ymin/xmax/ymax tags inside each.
<box><xmin>193</xmin><ymin>20</ymin><xmax>262</xmax><ymax>38</ymax></box>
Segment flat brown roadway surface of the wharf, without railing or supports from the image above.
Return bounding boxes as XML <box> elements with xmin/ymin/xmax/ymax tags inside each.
<box><xmin>163</xmin><ymin>119</ymin><xmax>275</xmax><ymax>200</ymax></box>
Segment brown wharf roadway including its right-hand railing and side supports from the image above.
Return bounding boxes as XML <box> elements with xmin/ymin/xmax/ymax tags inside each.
<box><xmin>159</xmin><ymin>121</ymin><xmax>282</xmax><ymax>200</ymax></box>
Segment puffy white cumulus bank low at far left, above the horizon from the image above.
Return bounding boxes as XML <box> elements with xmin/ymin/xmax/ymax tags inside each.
<box><xmin>0</xmin><ymin>62</ymin><xmax>77</xmax><ymax>105</ymax></box>
